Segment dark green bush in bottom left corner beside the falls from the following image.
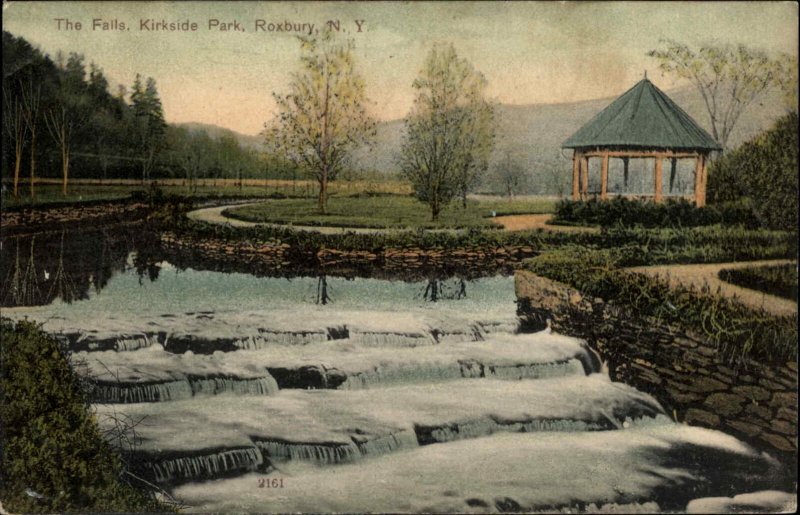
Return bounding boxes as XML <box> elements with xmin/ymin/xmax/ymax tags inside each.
<box><xmin>0</xmin><ymin>319</ymin><xmax>169</xmax><ymax>512</ymax></box>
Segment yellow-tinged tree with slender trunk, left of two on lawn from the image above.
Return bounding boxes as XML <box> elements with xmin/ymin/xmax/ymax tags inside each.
<box><xmin>266</xmin><ymin>30</ymin><xmax>375</xmax><ymax>214</ymax></box>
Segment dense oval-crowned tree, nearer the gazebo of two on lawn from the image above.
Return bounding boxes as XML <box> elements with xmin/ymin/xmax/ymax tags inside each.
<box><xmin>399</xmin><ymin>44</ymin><xmax>493</xmax><ymax>220</ymax></box>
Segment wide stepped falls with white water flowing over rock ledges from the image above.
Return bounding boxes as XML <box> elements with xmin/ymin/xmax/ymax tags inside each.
<box><xmin>6</xmin><ymin>271</ymin><xmax>776</xmax><ymax>513</ymax></box>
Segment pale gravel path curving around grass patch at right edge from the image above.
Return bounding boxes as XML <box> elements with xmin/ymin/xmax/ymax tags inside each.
<box><xmin>628</xmin><ymin>259</ymin><xmax>797</xmax><ymax>315</ymax></box>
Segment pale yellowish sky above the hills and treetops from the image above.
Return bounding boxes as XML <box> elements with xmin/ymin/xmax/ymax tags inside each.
<box><xmin>3</xmin><ymin>2</ymin><xmax>798</xmax><ymax>134</ymax></box>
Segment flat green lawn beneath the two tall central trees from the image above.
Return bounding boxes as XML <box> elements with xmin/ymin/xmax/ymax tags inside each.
<box><xmin>225</xmin><ymin>195</ymin><xmax>555</xmax><ymax>228</ymax></box>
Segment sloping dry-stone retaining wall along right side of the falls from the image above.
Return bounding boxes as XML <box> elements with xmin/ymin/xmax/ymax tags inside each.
<box><xmin>516</xmin><ymin>271</ymin><xmax>797</xmax><ymax>459</ymax></box>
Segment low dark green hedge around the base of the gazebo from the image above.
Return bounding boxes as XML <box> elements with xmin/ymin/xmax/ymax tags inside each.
<box><xmin>553</xmin><ymin>197</ymin><xmax>758</xmax><ymax>228</ymax></box>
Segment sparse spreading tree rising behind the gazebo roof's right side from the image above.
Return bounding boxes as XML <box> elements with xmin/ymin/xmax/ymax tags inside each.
<box><xmin>647</xmin><ymin>40</ymin><xmax>780</xmax><ymax>148</ymax></box>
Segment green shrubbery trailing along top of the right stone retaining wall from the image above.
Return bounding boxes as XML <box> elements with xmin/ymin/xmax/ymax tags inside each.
<box><xmin>526</xmin><ymin>246</ymin><xmax>797</xmax><ymax>363</ymax></box>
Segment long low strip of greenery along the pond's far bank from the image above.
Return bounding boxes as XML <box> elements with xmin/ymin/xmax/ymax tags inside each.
<box><xmin>169</xmin><ymin>212</ymin><xmax>797</xmax><ymax>266</ymax></box>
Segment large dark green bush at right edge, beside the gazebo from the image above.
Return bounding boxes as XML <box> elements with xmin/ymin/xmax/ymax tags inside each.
<box><xmin>708</xmin><ymin>111</ymin><xmax>798</xmax><ymax>231</ymax></box>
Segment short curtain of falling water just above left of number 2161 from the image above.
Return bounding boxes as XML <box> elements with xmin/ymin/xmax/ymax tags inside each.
<box><xmin>147</xmin><ymin>447</ymin><xmax>264</xmax><ymax>483</ymax></box>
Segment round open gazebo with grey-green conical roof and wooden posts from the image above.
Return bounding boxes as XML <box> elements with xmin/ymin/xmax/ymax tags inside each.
<box><xmin>561</xmin><ymin>77</ymin><xmax>722</xmax><ymax>206</ymax></box>
